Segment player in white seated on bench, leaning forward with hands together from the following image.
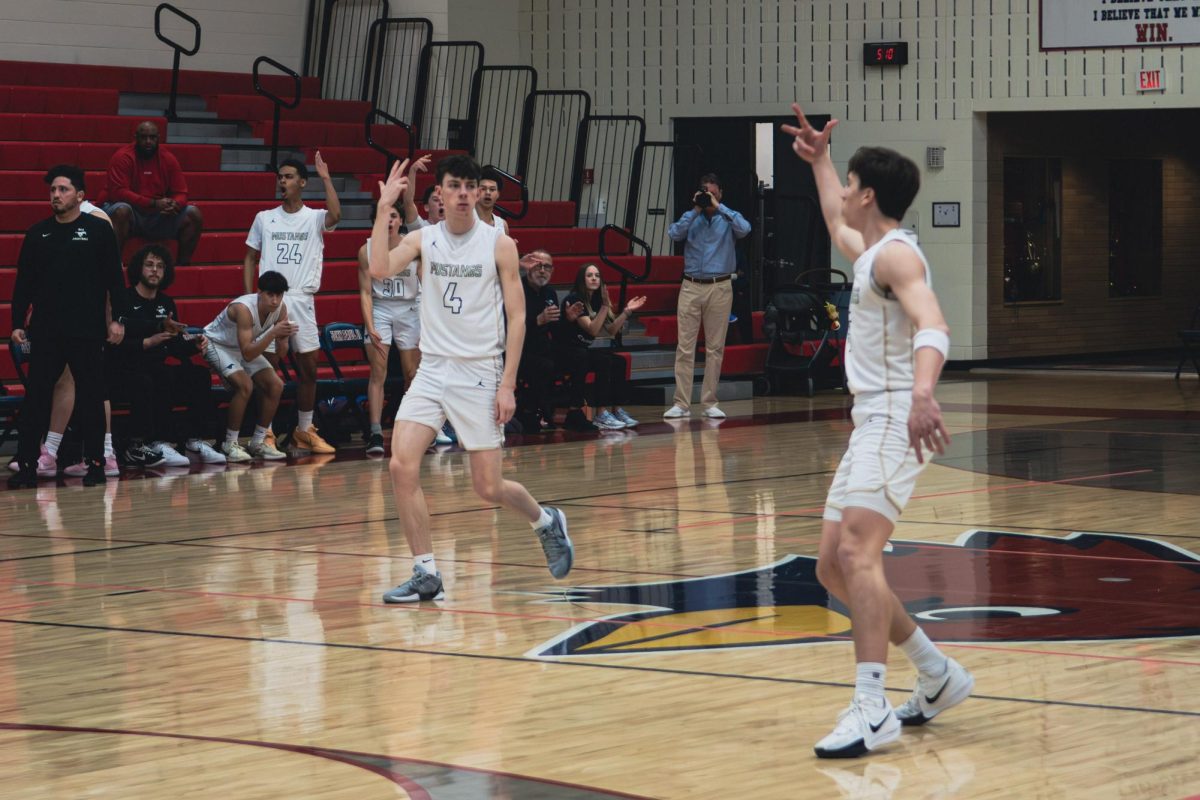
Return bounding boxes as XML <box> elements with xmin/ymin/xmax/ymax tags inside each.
<box><xmin>204</xmin><ymin>271</ymin><xmax>296</xmax><ymax>463</ymax></box>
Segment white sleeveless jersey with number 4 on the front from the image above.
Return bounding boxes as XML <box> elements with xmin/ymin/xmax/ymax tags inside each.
<box><xmin>421</xmin><ymin>222</ymin><xmax>505</xmax><ymax>359</ymax></box>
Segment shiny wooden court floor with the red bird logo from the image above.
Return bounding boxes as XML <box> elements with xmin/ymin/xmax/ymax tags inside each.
<box><xmin>0</xmin><ymin>374</ymin><xmax>1200</xmax><ymax>800</ymax></box>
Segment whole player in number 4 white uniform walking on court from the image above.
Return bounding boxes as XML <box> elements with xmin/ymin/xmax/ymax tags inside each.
<box><xmin>371</xmin><ymin>155</ymin><xmax>575</xmax><ymax>603</ymax></box>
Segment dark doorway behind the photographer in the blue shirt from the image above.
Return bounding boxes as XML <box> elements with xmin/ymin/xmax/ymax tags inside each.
<box><xmin>672</xmin><ymin>116</ymin><xmax>829</xmax><ymax>335</ymax></box>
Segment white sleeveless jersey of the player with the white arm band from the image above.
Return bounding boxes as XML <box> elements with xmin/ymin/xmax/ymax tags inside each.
<box><xmin>846</xmin><ymin>228</ymin><xmax>932</xmax><ymax>395</ymax></box>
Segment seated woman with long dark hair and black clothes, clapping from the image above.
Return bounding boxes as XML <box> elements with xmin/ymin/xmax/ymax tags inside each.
<box><xmin>554</xmin><ymin>264</ymin><xmax>646</xmax><ymax>431</ymax></box>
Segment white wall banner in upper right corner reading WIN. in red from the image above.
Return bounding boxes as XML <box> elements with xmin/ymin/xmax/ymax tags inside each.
<box><xmin>1040</xmin><ymin>0</ymin><xmax>1200</xmax><ymax>50</ymax></box>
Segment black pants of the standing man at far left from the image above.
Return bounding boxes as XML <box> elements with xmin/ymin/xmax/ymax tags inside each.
<box><xmin>17</xmin><ymin>336</ymin><xmax>104</xmax><ymax>464</ymax></box>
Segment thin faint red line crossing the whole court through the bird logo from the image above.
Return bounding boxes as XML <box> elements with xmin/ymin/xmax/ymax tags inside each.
<box><xmin>4</xmin><ymin>581</ymin><xmax>1200</xmax><ymax>667</ymax></box>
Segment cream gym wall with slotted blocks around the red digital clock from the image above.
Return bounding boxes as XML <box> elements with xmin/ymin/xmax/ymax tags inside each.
<box><xmin>521</xmin><ymin>0</ymin><xmax>1200</xmax><ymax>360</ymax></box>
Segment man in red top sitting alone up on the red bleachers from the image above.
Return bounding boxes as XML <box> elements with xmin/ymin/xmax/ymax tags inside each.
<box><xmin>104</xmin><ymin>122</ymin><xmax>204</xmax><ymax>265</ymax></box>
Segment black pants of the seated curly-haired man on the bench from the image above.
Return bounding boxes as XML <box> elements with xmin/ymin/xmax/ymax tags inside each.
<box><xmin>108</xmin><ymin>362</ymin><xmax>216</xmax><ymax>444</ymax></box>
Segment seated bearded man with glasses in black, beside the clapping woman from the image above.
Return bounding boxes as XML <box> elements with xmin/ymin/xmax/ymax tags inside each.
<box><xmin>516</xmin><ymin>249</ymin><xmax>587</xmax><ymax>433</ymax></box>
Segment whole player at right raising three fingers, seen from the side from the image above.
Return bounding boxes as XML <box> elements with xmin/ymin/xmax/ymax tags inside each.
<box><xmin>784</xmin><ymin>103</ymin><xmax>974</xmax><ymax>758</ymax></box>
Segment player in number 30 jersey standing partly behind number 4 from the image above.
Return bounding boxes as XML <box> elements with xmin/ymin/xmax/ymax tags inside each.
<box><xmin>359</xmin><ymin>195</ymin><xmax>421</xmax><ymax>456</ymax></box>
